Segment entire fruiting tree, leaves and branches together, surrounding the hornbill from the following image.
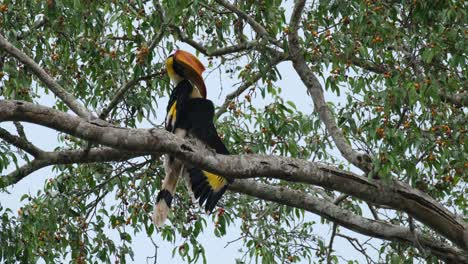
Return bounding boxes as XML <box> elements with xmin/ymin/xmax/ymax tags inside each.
<box><xmin>0</xmin><ymin>0</ymin><xmax>468</xmax><ymax>263</ymax></box>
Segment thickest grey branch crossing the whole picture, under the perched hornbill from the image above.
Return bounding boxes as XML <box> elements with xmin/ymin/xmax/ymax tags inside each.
<box><xmin>0</xmin><ymin>100</ymin><xmax>468</xmax><ymax>249</ymax></box>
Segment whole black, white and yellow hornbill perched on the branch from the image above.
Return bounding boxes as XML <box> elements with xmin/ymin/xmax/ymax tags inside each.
<box><xmin>153</xmin><ymin>50</ymin><xmax>232</xmax><ymax>226</ymax></box>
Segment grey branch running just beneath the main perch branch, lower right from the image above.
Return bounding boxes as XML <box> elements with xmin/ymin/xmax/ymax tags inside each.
<box><xmin>229</xmin><ymin>180</ymin><xmax>468</xmax><ymax>263</ymax></box>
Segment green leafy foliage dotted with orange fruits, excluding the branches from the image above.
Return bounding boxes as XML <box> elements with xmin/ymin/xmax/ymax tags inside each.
<box><xmin>0</xmin><ymin>0</ymin><xmax>468</xmax><ymax>263</ymax></box>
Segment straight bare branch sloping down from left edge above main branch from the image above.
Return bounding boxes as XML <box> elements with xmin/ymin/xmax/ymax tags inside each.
<box><xmin>0</xmin><ymin>34</ymin><xmax>92</xmax><ymax>118</ymax></box>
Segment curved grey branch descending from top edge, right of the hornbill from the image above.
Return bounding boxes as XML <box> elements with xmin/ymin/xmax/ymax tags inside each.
<box><xmin>288</xmin><ymin>0</ymin><xmax>371</xmax><ymax>173</ymax></box>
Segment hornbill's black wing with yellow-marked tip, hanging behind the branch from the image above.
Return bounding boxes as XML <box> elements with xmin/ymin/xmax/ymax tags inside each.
<box><xmin>186</xmin><ymin>98</ymin><xmax>232</xmax><ymax>212</ymax></box>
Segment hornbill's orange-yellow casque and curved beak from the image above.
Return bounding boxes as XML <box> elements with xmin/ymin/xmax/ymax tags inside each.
<box><xmin>166</xmin><ymin>50</ymin><xmax>206</xmax><ymax>98</ymax></box>
